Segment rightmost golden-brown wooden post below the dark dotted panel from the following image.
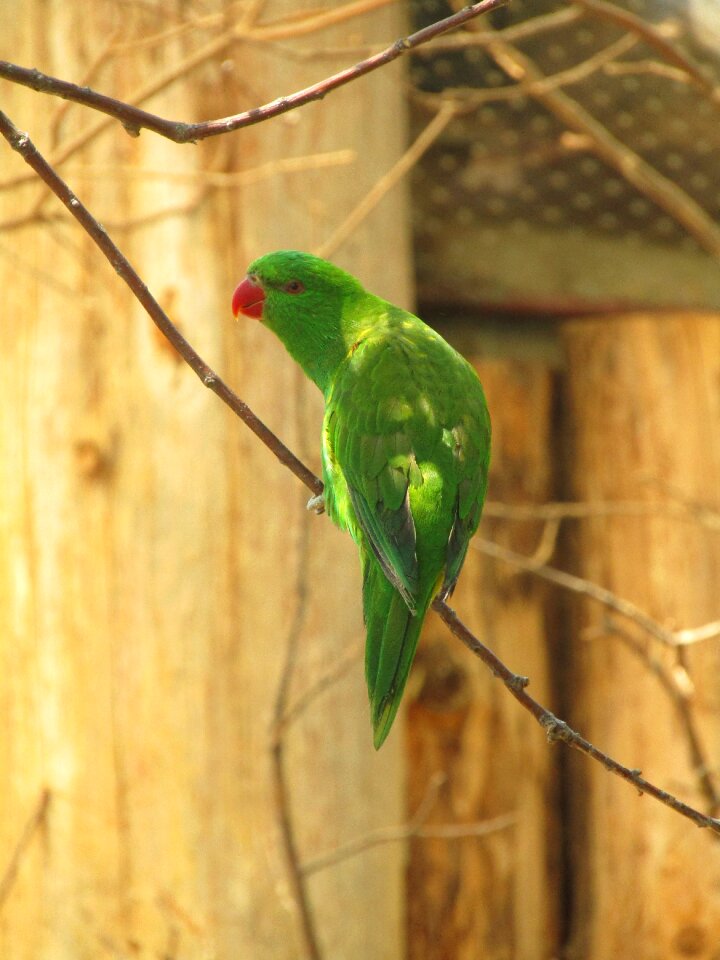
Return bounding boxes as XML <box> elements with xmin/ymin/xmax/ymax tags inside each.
<box><xmin>563</xmin><ymin>315</ymin><xmax>720</xmax><ymax>960</ymax></box>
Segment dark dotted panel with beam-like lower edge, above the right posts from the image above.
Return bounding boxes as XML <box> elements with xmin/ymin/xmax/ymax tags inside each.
<box><xmin>411</xmin><ymin>0</ymin><xmax>720</xmax><ymax>312</ymax></box>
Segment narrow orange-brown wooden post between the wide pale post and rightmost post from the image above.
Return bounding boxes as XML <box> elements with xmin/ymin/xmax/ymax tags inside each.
<box><xmin>408</xmin><ymin>344</ymin><xmax>560</xmax><ymax>960</ymax></box>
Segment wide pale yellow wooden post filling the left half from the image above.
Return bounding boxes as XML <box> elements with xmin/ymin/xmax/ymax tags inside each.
<box><xmin>0</xmin><ymin>2</ymin><xmax>409</xmax><ymax>960</ymax></box>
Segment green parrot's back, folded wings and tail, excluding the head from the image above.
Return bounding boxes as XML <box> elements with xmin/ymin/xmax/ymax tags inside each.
<box><xmin>323</xmin><ymin>310</ymin><xmax>489</xmax><ymax>745</ymax></box>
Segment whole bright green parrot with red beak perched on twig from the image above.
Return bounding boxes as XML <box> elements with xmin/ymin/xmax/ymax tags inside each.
<box><xmin>232</xmin><ymin>250</ymin><xmax>490</xmax><ymax>749</ymax></box>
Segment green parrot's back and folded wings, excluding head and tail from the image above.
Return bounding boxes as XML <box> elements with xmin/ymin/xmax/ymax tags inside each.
<box><xmin>324</xmin><ymin>310</ymin><xmax>490</xmax><ymax>588</ymax></box>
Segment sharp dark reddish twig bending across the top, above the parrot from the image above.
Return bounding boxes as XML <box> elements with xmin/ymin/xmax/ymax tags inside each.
<box><xmin>0</xmin><ymin>0</ymin><xmax>509</xmax><ymax>143</ymax></box>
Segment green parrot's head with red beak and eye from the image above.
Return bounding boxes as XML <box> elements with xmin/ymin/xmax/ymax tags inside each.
<box><xmin>232</xmin><ymin>250</ymin><xmax>369</xmax><ymax>390</ymax></box>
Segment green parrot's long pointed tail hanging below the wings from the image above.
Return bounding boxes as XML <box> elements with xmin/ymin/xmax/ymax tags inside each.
<box><xmin>363</xmin><ymin>558</ymin><xmax>429</xmax><ymax>750</ymax></box>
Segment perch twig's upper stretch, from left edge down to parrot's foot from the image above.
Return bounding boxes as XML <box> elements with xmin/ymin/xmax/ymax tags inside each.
<box><xmin>0</xmin><ymin>111</ymin><xmax>322</xmax><ymax>494</ymax></box>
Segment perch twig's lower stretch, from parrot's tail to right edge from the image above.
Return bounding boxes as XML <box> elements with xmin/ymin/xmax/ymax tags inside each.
<box><xmin>433</xmin><ymin>600</ymin><xmax>720</xmax><ymax>835</ymax></box>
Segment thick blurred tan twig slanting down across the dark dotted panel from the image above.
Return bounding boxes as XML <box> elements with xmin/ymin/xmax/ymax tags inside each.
<box><xmin>488</xmin><ymin>40</ymin><xmax>720</xmax><ymax>258</ymax></box>
